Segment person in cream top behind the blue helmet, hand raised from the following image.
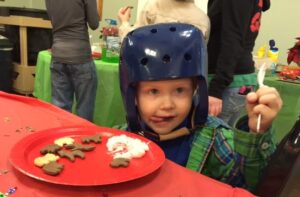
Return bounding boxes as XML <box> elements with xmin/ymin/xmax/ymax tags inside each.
<box><xmin>118</xmin><ymin>0</ymin><xmax>210</xmax><ymax>41</ymax></box>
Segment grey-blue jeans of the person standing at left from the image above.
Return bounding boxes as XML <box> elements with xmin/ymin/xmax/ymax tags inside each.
<box><xmin>50</xmin><ymin>61</ymin><xmax>97</xmax><ymax>122</ymax></box>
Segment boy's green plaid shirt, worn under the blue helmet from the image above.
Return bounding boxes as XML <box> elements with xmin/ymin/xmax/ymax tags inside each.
<box><xmin>186</xmin><ymin>117</ymin><xmax>276</xmax><ymax>191</ymax></box>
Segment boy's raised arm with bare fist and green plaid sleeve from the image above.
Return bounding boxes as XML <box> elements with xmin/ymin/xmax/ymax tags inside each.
<box><xmin>234</xmin><ymin>87</ymin><xmax>282</xmax><ymax>190</ymax></box>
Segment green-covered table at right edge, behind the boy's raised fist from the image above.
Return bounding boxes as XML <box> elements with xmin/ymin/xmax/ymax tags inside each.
<box><xmin>264</xmin><ymin>77</ymin><xmax>300</xmax><ymax>142</ymax></box>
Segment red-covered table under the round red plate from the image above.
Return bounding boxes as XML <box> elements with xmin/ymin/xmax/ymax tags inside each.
<box><xmin>0</xmin><ymin>92</ymin><xmax>253</xmax><ymax>197</ymax></box>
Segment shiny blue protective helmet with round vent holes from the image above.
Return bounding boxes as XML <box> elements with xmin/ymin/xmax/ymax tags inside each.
<box><xmin>120</xmin><ymin>23</ymin><xmax>208</xmax><ymax>131</ymax></box>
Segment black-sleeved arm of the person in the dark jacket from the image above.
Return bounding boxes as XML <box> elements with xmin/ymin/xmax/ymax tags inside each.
<box><xmin>209</xmin><ymin>0</ymin><xmax>254</xmax><ymax>99</ymax></box>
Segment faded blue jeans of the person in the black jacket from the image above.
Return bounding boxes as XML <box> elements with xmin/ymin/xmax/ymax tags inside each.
<box><xmin>218</xmin><ymin>87</ymin><xmax>246</xmax><ymax>126</ymax></box>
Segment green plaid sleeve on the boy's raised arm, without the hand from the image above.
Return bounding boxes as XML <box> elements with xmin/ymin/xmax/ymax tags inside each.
<box><xmin>232</xmin><ymin>124</ymin><xmax>276</xmax><ymax>191</ymax></box>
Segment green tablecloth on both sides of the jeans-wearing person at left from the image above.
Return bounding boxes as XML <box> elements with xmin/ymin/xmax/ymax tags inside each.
<box><xmin>33</xmin><ymin>51</ymin><xmax>125</xmax><ymax>127</ymax></box>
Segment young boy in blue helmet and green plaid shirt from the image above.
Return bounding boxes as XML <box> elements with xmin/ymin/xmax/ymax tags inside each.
<box><xmin>120</xmin><ymin>23</ymin><xmax>282</xmax><ymax>190</ymax></box>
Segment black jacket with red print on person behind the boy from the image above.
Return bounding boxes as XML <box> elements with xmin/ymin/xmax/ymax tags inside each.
<box><xmin>207</xmin><ymin>0</ymin><xmax>270</xmax><ymax>98</ymax></box>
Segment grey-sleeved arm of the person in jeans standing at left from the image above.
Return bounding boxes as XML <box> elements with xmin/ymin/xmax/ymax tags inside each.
<box><xmin>85</xmin><ymin>0</ymin><xmax>99</xmax><ymax>30</ymax></box>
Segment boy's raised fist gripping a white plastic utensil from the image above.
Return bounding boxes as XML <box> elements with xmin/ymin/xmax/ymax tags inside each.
<box><xmin>246</xmin><ymin>86</ymin><xmax>282</xmax><ymax>132</ymax></box>
